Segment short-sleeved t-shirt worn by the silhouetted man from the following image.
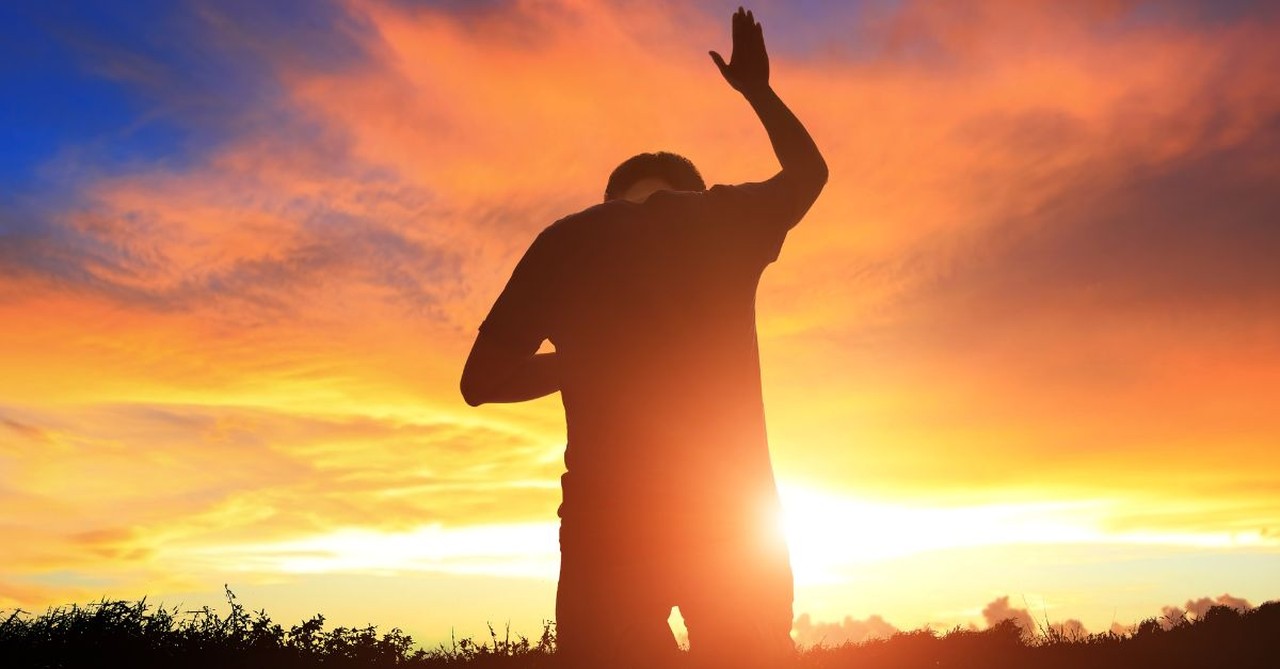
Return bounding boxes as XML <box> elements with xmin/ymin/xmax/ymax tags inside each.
<box><xmin>481</xmin><ymin>175</ymin><xmax>809</xmax><ymax>549</ymax></box>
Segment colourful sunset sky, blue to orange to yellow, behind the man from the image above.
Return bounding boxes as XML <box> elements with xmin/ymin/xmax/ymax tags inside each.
<box><xmin>0</xmin><ymin>0</ymin><xmax>1280</xmax><ymax>645</ymax></box>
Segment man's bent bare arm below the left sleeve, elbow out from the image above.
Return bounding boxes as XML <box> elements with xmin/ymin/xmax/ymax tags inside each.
<box><xmin>460</xmin><ymin>333</ymin><xmax>559</xmax><ymax>407</ymax></box>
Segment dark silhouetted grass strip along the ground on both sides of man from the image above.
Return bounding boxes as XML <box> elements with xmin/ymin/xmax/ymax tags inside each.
<box><xmin>0</xmin><ymin>590</ymin><xmax>1280</xmax><ymax>669</ymax></box>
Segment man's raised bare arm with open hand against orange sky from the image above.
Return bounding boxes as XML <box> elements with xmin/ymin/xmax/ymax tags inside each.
<box><xmin>710</xmin><ymin>8</ymin><xmax>827</xmax><ymax>209</ymax></box>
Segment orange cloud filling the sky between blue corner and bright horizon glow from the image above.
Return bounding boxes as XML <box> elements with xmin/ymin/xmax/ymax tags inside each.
<box><xmin>0</xmin><ymin>0</ymin><xmax>1280</xmax><ymax>634</ymax></box>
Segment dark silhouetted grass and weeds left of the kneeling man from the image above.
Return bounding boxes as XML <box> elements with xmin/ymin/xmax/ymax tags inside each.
<box><xmin>0</xmin><ymin>590</ymin><xmax>554</xmax><ymax>669</ymax></box>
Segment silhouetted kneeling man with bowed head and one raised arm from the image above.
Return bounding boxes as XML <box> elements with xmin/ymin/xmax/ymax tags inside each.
<box><xmin>462</xmin><ymin>9</ymin><xmax>827</xmax><ymax>668</ymax></box>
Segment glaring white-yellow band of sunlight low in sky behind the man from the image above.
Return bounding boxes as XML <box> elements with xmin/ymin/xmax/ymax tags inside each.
<box><xmin>174</xmin><ymin>485</ymin><xmax>1277</xmax><ymax>586</ymax></box>
